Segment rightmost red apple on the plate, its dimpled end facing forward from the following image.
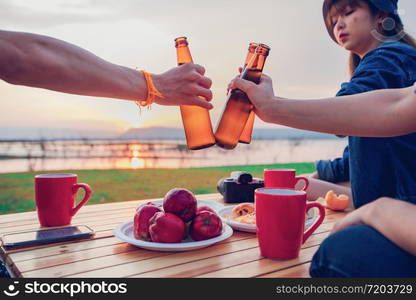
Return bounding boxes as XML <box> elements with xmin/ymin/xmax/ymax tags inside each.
<box><xmin>189</xmin><ymin>211</ymin><xmax>222</xmax><ymax>241</ymax></box>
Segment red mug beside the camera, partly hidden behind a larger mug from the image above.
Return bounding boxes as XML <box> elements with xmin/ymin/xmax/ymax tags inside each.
<box><xmin>264</xmin><ymin>169</ymin><xmax>309</xmax><ymax>191</ymax></box>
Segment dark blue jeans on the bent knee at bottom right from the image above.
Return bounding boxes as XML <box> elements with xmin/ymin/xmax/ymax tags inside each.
<box><xmin>309</xmin><ymin>225</ymin><xmax>416</xmax><ymax>277</ymax></box>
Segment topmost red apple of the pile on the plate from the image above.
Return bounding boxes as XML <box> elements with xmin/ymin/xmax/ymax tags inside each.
<box><xmin>163</xmin><ymin>188</ymin><xmax>197</xmax><ymax>223</ymax></box>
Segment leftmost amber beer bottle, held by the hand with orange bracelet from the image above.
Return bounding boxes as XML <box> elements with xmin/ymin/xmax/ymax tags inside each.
<box><xmin>175</xmin><ymin>37</ymin><xmax>215</xmax><ymax>150</ymax></box>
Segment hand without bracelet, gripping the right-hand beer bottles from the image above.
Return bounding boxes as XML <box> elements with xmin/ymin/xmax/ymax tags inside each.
<box><xmin>228</xmin><ymin>74</ymin><xmax>278</xmax><ymax>122</ymax></box>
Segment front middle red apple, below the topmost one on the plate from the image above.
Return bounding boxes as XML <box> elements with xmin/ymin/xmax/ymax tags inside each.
<box><xmin>149</xmin><ymin>212</ymin><xmax>186</xmax><ymax>243</ymax></box>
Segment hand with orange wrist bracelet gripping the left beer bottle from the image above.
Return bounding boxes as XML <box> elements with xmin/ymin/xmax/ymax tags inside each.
<box><xmin>153</xmin><ymin>63</ymin><xmax>213</xmax><ymax>109</ymax></box>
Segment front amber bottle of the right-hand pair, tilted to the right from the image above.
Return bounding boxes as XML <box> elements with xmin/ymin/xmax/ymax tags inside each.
<box><xmin>215</xmin><ymin>44</ymin><xmax>270</xmax><ymax>149</ymax></box>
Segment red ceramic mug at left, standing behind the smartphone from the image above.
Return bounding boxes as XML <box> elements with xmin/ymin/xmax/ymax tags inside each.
<box><xmin>35</xmin><ymin>174</ymin><xmax>92</xmax><ymax>227</ymax></box>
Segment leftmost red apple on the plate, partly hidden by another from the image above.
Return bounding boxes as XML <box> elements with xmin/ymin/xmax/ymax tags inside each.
<box><xmin>133</xmin><ymin>203</ymin><xmax>162</xmax><ymax>241</ymax></box>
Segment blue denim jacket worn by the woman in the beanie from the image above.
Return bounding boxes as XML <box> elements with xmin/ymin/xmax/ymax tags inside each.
<box><xmin>316</xmin><ymin>42</ymin><xmax>416</xmax><ymax>207</ymax></box>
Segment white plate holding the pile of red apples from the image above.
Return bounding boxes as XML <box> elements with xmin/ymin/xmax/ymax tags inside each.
<box><xmin>114</xmin><ymin>221</ymin><xmax>233</xmax><ymax>251</ymax></box>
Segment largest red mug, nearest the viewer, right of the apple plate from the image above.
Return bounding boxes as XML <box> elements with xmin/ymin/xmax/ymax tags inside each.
<box><xmin>255</xmin><ymin>188</ymin><xmax>325</xmax><ymax>259</ymax></box>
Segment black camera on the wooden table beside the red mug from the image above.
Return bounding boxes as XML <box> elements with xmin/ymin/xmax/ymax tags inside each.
<box><xmin>217</xmin><ymin>171</ymin><xmax>264</xmax><ymax>203</ymax></box>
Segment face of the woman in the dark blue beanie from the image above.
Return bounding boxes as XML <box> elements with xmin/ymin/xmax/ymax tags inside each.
<box><xmin>329</xmin><ymin>2</ymin><xmax>380</xmax><ymax>55</ymax></box>
